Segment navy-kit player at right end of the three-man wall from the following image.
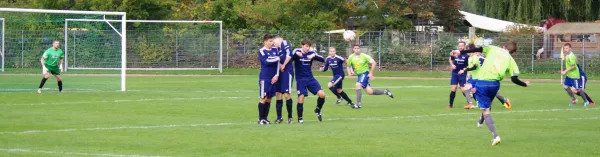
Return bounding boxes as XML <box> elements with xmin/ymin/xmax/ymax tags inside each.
<box><xmin>292</xmin><ymin>39</ymin><xmax>325</xmax><ymax>124</ymax></box>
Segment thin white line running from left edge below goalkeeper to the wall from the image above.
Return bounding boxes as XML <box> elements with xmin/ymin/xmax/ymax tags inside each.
<box><xmin>0</xmin><ymin>97</ymin><xmax>254</xmax><ymax>106</ymax></box>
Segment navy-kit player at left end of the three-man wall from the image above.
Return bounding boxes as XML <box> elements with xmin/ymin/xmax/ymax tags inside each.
<box><xmin>258</xmin><ymin>34</ymin><xmax>279</xmax><ymax>125</ymax></box>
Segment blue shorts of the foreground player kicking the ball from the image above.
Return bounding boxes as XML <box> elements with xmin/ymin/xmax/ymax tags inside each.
<box><xmin>475</xmin><ymin>80</ymin><xmax>500</xmax><ymax>110</ymax></box>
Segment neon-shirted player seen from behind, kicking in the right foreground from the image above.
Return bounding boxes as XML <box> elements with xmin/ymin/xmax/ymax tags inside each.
<box><xmin>453</xmin><ymin>41</ymin><xmax>529</xmax><ymax>145</ymax></box>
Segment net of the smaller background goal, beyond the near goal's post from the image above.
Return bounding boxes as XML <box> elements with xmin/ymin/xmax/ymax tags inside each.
<box><xmin>65</xmin><ymin>19</ymin><xmax>223</xmax><ymax>71</ymax></box>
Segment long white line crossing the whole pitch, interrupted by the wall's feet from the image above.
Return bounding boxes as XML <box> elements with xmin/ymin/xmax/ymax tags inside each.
<box><xmin>0</xmin><ymin>108</ymin><xmax>600</xmax><ymax>135</ymax></box>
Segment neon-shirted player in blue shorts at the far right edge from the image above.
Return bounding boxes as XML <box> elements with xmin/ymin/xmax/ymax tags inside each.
<box><xmin>561</xmin><ymin>43</ymin><xmax>590</xmax><ymax>106</ymax></box>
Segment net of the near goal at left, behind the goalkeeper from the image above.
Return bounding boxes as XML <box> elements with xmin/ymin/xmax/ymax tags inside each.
<box><xmin>0</xmin><ymin>8</ymin><xmax>127</xmax><ymax>91</ymax></box>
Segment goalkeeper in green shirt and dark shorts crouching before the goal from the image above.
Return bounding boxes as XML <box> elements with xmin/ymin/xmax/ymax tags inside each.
<box><xmin>38</xmin><ymin>40</ymin><xmax>65</xmax><ymax>93</ymax></box>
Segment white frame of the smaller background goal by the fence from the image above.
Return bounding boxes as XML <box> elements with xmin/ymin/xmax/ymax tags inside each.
<box><xmin>64</xmin><ymin>19</ymin><xmax>223</xmax><ymax>73</ymax></box>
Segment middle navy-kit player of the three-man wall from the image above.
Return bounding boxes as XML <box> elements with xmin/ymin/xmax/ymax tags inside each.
<box><xmin>273</xmin><ymin>36</ymin><xmax>294</xmax><ymax>124</ymax></box>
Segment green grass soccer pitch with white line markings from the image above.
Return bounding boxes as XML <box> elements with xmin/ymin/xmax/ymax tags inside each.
<box><xmin>0</xmin><ymin>75</ymin><xmax>600</xmax><ymax>157</ymax></box>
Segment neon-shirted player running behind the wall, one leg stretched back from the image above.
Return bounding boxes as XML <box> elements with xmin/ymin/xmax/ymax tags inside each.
<box><xmin>346</xmin><ymin>45</ymin><xmax>394</xmax><ymax>109</ymax></box>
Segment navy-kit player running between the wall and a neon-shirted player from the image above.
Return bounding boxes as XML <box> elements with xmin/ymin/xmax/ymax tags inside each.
<box><xmin>320</xmin><ymin>47</ymin><xmax>354</xmax><ymax>106</ymax></box>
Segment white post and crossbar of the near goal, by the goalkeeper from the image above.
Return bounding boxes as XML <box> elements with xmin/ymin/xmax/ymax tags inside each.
<box><xmin>0</xmin><ymin>8</ymin><xmax>127</xmax><ymax>91</ymax></box>
